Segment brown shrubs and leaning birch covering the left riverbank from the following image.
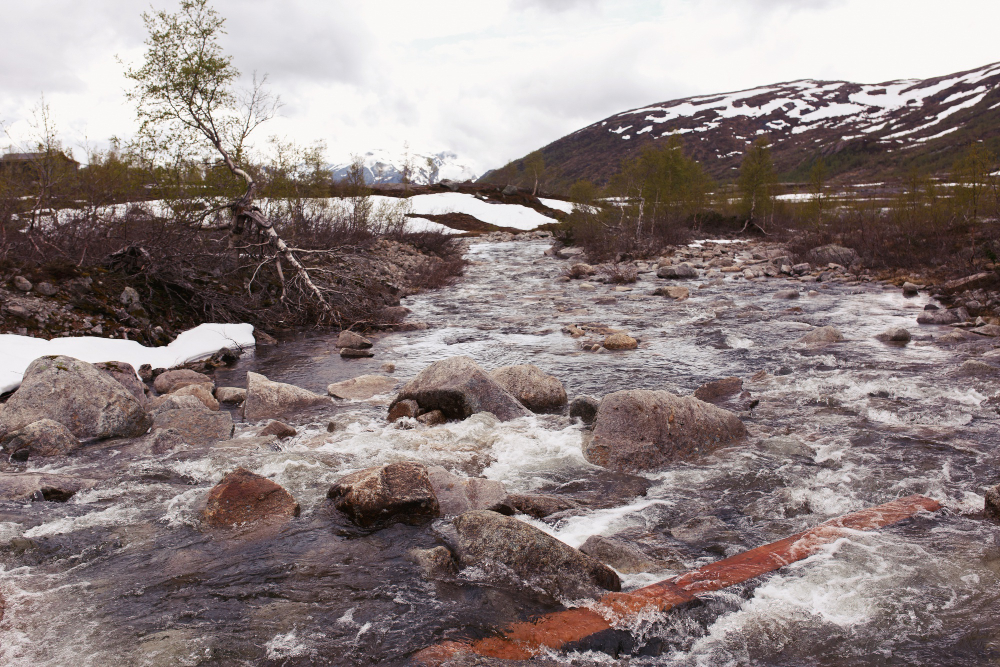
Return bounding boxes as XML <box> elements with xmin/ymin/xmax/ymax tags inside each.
<box><xmin>0</xmin><ymin>0</ymin><xmax>463</xmax><ymax>343</ymax></box>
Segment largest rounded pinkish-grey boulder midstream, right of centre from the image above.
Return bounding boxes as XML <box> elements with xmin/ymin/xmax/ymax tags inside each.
<box><xmin>583</xmin><ymin>389</ymin><xmax>746</xmax><ymax>472</ymax></box>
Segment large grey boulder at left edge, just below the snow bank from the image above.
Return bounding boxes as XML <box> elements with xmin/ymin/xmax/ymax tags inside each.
<box><xmin>0</xmin><ymin>356</ymin><xmax>149</xmax><ymax>440</ymax></box>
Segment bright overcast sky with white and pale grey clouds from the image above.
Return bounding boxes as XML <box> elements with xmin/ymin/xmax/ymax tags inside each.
<box><xmin>0</xmin><ymin>0</ymin><xmax>1000</xmax><ymax>170</ymax></box>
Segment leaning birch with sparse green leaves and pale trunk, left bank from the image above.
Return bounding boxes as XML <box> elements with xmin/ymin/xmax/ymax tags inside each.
<box><xmin>126</xmin><ymin>0</ymin><xmax>328</xmax><ymax>319</ymax></box>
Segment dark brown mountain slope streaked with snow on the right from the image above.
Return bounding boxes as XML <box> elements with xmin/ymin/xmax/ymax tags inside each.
<box><xmin>491</xmin><ymin>63</ymin><xmax>1000</xmax><ymax>187</ymax></box>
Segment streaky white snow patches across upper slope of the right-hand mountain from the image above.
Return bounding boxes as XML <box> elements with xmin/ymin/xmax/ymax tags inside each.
<box><xmin>581</xmin><ymin>63</ymin><xmax>1000</xmax><ymax>157</ymax></box>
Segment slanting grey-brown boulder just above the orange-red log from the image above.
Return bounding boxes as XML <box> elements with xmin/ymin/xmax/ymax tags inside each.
<box><xmin>453</xmin><ymin>510</ymin><xmax>621</xmax><ymax>600</ymax></box>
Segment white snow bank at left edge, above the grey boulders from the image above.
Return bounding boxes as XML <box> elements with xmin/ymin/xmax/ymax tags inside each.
<box><xmin>0</xmin><ymin>324</ymin><xmax>256</xmax><ymax>392</ymax></box>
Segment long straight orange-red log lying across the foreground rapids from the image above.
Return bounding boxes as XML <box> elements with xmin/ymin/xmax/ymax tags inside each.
<box><xmin>413</xmin><ymin>495</ymin><xmax>941</xmax><ymax>667</ymax></box>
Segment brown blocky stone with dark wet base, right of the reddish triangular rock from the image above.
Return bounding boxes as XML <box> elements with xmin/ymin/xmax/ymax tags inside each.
<box><xmin>326</xmin><ymin>461</ymin><xmax>441</xmax><ymax>528</ymax></box>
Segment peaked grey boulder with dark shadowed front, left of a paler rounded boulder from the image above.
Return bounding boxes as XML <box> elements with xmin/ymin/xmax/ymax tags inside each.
<box><xmin>389</xmin><ymin>357</ymin><xmax>531</xmax><ymax>421</ymax></box>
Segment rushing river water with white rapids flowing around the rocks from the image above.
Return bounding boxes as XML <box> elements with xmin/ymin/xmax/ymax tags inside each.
<box><xmin>0</xmin><ymin>242</ymin><xmax>1000</xmax><ymax>666</ymax></box>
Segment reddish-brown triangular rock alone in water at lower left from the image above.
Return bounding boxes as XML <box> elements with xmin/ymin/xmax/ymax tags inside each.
<box><xmin>204</xmin><ymin>468</ymin><xmax>299</xmax><ymax>528</ymax></box>
